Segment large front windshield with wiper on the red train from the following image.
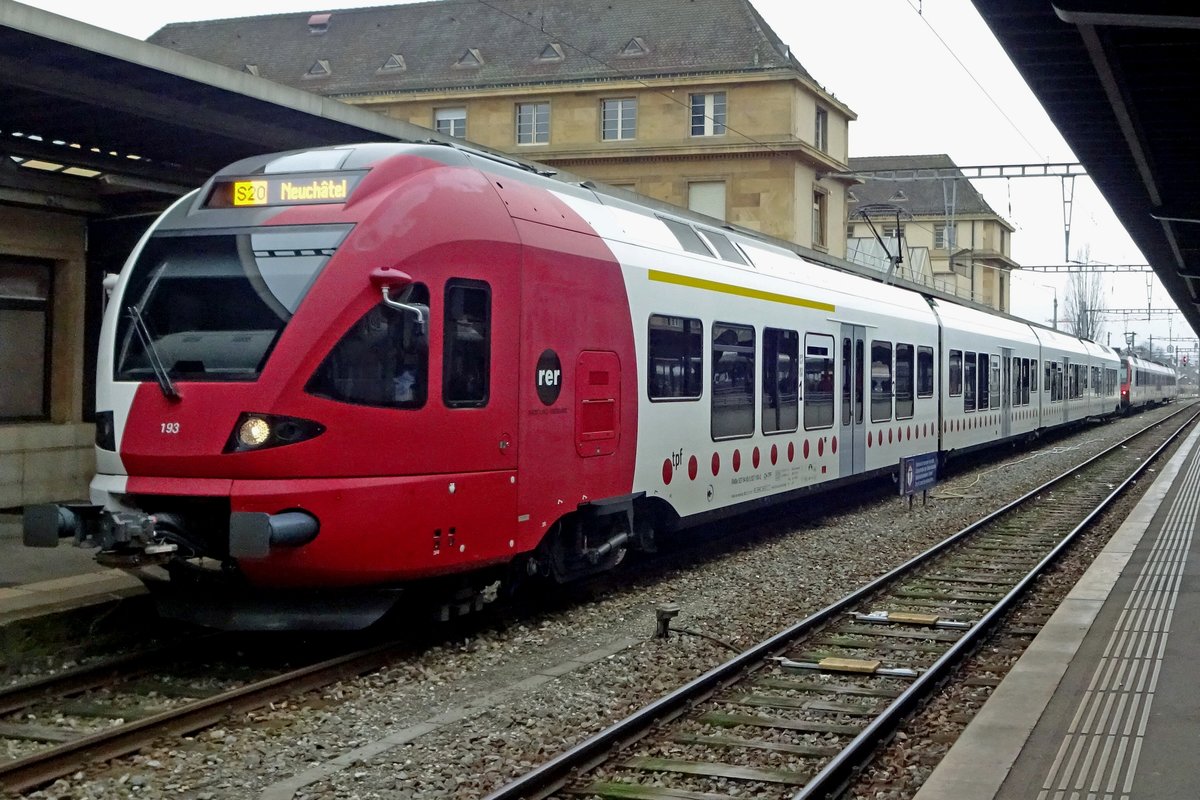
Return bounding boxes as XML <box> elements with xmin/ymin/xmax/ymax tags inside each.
<box><xmin>114</xmin><ymin>225</ymin><xmax>350</xmax><ymax>380</ymax></box>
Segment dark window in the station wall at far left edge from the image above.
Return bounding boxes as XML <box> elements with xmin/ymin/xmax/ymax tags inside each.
<box><xmin>0</xmin><ymin>258</ymin><xmax>53</xmax><ymax>420</ymax></box>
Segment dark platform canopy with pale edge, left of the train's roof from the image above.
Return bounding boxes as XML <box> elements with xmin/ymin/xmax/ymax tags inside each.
<box><xmin>0</xmin><ymin>0</ymin><xmax>445</xmax><ymax>216</ymax></box>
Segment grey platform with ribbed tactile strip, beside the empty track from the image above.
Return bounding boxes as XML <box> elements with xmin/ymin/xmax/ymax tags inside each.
<box><xmin>916</xmin><ymin>429</ymin><xmax>1200</xmax><ymax>800</ymax></box>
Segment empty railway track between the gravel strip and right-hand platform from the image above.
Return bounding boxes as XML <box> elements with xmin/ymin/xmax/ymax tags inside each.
<box><xmin>486</xmin><ymin>407</ymin><xmax>1200</xmax><ymax>800</ymax></box>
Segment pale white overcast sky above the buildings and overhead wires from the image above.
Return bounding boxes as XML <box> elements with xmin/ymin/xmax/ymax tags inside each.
<box><xmin>16</xmin><ymin>0</ymin><xmax>1194</xmax><ymax>352</ymax></box>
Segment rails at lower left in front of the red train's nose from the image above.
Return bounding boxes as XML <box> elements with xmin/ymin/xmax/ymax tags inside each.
<box><xmin>0</xmin><ymin>634</ymin><xmax>410</xmax><ymax>792</ymax></box>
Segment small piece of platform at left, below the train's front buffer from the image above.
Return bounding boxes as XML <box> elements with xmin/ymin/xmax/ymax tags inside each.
<box><xmin>0</xmin><ymin>513</ymin><xmax>145</xmax><ymax>626</ymax></box>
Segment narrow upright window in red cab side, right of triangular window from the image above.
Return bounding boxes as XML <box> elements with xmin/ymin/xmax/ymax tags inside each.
<box><xmin>442</xmin><ymin>281</ymin><xmax>492</xmax><ymax>408</ymax></box>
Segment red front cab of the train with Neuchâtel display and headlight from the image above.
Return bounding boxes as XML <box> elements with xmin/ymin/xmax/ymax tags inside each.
<box><xmin>26</xmin><ymin>145</ymin><xmax>556</xmax><ymax>627</ymax></box>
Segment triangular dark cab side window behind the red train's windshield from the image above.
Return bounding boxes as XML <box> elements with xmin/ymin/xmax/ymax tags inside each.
<box><xmin>305</xmin><ymin>283</ymin><xmax>430</xmax><ymax>409</ymax></box>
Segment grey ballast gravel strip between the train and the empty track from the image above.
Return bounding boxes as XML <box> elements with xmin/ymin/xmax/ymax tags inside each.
<box><xmin>26</xmin><ymin>410</ymin><xmax>1185</xmax><ymax>800</ymax></box>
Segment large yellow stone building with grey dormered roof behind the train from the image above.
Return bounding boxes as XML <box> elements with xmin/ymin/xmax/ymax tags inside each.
<box><xmin>148</xmin><ymin>0</ymin><xmax>856</xmax><ymax>257</ymax></box>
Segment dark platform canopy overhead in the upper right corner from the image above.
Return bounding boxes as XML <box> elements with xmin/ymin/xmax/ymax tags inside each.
<box><xmin>973</xmin><ymin>0</ymin><xmax>1200</xmax><ymax>332</ymax></box>
